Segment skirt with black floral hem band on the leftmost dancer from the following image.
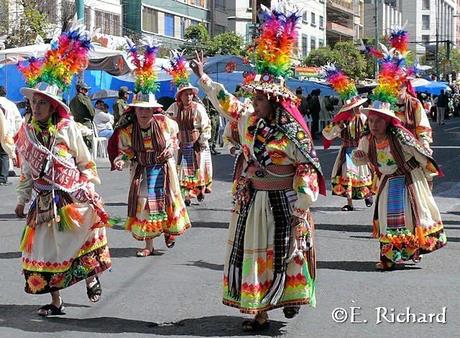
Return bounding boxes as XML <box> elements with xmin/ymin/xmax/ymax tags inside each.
<box><xmin>20</xmin><ymin>192</ymin><xmax>111</xmax><ymax>294</ymax></box>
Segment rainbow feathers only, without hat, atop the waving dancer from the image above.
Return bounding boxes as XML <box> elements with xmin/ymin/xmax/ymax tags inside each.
<box><xmin>255</xmin><ymin>1</ymin><xmax>302</xmax><ymax>77</ymax></box>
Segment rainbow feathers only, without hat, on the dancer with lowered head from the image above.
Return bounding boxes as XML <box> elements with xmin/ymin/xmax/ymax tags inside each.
<box><xmin>125</xmin><ymin>37</ymin><xmax>159</xmax><ymax>94</ymax></box>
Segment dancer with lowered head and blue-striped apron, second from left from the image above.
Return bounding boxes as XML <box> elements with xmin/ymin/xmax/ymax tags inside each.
<box><xmin>111</xmin><ymin>39</ymin><xmax>190</xmax><ymax>257</ymax></box>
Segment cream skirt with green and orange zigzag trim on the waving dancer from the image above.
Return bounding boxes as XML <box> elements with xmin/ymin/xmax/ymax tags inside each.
<box><xmin>223</xmin><ymin>191</ymin><xmax>316</xmax><ymax>314</ymax></box>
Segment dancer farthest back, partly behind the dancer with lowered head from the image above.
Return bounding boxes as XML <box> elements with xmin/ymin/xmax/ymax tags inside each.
<box><xmin>166</xmin><ymin>51</ymin><xmax>212</xmax><ymax>205</ymax></box>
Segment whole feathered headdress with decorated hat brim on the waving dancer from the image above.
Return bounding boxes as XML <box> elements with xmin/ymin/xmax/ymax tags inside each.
<box><xmin>244</xmin><ymin>1</ymin><xmax>302</xmax><ymax>101</ymax></box>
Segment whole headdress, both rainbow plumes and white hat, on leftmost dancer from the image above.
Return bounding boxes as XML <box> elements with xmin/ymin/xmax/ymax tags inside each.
<box><xmin>18</xmin><ymin>22</ymin><xmax>92</xmax><ymax>113</ymax></box>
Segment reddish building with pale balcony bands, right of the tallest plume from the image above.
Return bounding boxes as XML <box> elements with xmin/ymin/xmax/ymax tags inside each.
<box><xmin>326</xmin><ymin>0</ymin><xmax>364</xmax><ymax>46</ymax></box>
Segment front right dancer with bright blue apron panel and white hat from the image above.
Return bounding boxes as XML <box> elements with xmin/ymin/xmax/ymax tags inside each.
<box><xmin>352</xmin><ymin>45</ymin><xmax>447</xmax><ymax>270</ymax></box>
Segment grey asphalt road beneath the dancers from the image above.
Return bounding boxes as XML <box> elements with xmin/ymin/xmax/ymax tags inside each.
<box><xmin>0</xmin><ymin>118</ymin><xmax>460</xmax><ymax>337</ymax></box>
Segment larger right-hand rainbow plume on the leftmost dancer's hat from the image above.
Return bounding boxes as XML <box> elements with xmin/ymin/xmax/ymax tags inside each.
<box><xmin>39</xmin><ymin>23</ymin><xmax>92</xmax><ymax>90</ymax></box>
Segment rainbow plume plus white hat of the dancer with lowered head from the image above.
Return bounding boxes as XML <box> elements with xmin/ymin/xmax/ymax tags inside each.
<box><xmin>125</xmin><ymin>37</ymin><xmax>163</xmax><ymax>108</ymax></box>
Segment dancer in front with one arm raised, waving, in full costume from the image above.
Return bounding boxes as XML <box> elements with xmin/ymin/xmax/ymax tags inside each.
<box><xmin>191</xmin><ymin>2</ymin><xmax>325</xmax><ymax>331</ymax></box>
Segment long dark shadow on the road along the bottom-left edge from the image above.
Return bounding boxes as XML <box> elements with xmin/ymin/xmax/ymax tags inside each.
<box><xmin>0</xmin><ymin>304</ymin><xmax>285</xmax><ymax>337</ymax></box>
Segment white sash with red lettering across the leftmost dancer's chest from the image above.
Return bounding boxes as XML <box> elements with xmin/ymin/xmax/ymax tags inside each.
<box><xmin>16</xmin><ymin>125</ymin><xmax>82</xmax><ymax>192</ymax></box>
